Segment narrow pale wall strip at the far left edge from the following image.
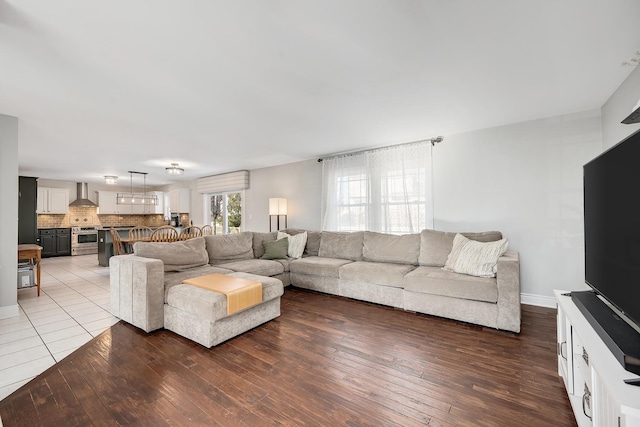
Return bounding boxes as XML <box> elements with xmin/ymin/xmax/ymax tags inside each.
<box><xmin>0</xmin><ymin>114</ymin><xmax>19</xmax><ymax>319</ymax></box>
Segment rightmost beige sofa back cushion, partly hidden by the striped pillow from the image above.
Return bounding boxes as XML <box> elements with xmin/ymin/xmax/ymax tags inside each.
<box><xmin>418</xmin><ymin>230</ymin><xmax>502</xmax><ymax>267</ymax></box>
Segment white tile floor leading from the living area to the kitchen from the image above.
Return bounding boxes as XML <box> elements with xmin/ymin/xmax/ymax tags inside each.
<box><xmin>0</xmin><ymin>255</ymin><xmax>118</xmax><ymax>400</ymax></box>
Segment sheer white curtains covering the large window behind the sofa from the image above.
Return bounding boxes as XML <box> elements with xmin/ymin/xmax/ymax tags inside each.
<box><xmin>322</xmin><ymin>141</ymin><xmax>433</xmax><ymax>234</ymax></box>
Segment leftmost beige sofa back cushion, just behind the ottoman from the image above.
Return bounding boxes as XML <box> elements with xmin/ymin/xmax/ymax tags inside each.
<box><xmin>133</xmin><ymin>237</ymin><xmax>209</xmax><ymax>271</ymax></box>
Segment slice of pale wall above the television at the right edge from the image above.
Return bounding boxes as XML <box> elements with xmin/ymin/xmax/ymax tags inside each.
<box><xmin>602</xmin><ymin>67</ymin><xmax>640</xmax><ymax>151</ymax></box>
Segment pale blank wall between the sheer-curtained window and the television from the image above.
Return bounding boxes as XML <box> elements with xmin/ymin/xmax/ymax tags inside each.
<box><xmin>434</xmin><ymin>110</ymin><xmax>602</xmax><ymax>305</ymax></box>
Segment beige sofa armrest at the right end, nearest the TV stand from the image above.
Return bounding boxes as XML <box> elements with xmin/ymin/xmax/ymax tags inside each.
<box><xmin>496</xmin><ymin>251</ymin><xmax>521</xmax><ymax>332</ymax></box>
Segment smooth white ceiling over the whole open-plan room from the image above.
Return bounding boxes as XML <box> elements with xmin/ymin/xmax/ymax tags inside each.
<box><xmin>0</xmin><ymin>0</ymin><xmax>640</xmax><ymax>185</ymax></box>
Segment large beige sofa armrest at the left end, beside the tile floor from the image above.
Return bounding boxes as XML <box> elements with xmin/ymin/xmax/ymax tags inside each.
<box><xmin>109</xmin><ymin>255</ymin><xmax>164</xmax><ymax>332</ymax></box>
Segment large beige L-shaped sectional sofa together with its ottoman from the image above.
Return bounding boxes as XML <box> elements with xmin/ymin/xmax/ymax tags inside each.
<box><xmin>110</xmin><ymin>229</ymin><xmax>520</xmax><ymax>346</ymax></box>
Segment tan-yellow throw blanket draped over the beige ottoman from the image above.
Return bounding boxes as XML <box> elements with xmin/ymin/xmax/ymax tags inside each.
<box><xmin>182</xmin><ymin>274</ymin><xmax>262</xmax><ymax>314</ymax></box>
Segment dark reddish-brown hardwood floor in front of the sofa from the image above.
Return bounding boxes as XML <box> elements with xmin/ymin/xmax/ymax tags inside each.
<box><xmin>0</xmin><ymin>287</ymin><xmax>576</xmax><ymax>427</ymax></box>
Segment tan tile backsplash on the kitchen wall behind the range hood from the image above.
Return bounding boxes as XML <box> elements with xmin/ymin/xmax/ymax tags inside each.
<box><xmin>38</xmin><ymin>206</ymin><xmax>189</xmax><ymax>228</ymax></box>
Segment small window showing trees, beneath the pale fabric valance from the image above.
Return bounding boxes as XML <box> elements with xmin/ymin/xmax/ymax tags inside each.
<box><xmin>204</xmin><ymin>192</ymin><xmax>244</xmax><ymax>234</ymax></box>
